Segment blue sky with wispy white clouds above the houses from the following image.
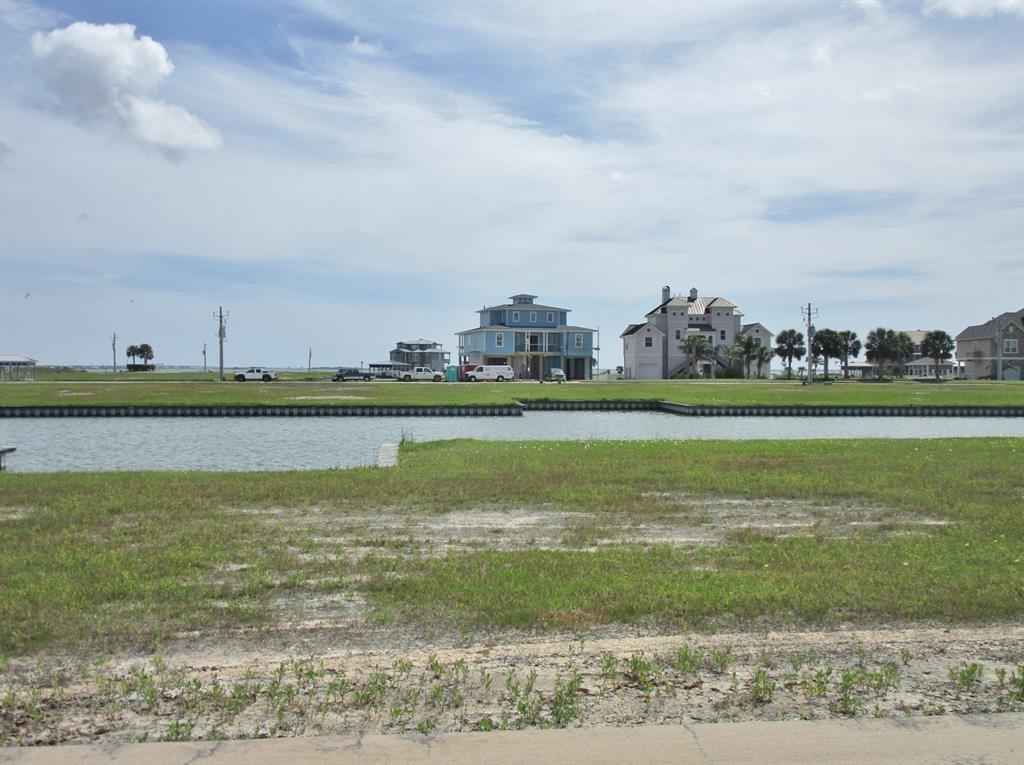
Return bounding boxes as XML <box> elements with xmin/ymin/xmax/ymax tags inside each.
<box><xmin>0</xmin><ymin>0</ymin><xmax>1024</xmax><ymax>367</ymax></box>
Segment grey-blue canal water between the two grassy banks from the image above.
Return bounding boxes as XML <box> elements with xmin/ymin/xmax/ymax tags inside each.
<box><xmin>0</xmin><ymin>412</ymin><xmax>1024</xmax><ymax>473</ymax></box>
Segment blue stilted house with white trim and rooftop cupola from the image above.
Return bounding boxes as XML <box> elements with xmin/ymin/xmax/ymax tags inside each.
<box><xmin>458</xmin><ymin>295</ymin><xmax>596</xmax><ymax>380</ymax></box>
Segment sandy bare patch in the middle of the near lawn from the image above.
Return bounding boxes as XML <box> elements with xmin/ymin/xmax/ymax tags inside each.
<box><xmin>228</xmin><ymin>494</ymin><xmax>949</xmax><ymax>560</ymax></box>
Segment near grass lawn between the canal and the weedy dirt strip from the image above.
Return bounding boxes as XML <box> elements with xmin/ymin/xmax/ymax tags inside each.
<box><xmin>0</xmin><ymin>440</ymin><xmax>1024</xmax><ymax>654</ymax></box>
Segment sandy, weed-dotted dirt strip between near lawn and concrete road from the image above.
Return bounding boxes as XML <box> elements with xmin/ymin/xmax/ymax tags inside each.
<box><xmin>0</xmin><ymin>620</ymin><xmax>1024</xmax><ymax>745</ymax></box>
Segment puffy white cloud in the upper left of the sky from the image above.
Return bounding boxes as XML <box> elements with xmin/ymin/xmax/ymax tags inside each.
<box><xmin>32</xmin><ymin>22</ymin><xmax>221</xmax><ymax>155</ymax></box>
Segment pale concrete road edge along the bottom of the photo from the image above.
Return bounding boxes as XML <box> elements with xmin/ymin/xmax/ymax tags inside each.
<box><xmin>0</xmin><ymin>714</ymin><xmax>1024</xmax><ymax>765</ymax></box>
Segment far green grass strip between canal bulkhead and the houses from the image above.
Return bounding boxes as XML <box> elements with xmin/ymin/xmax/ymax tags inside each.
<box><xmin>0</xmin><ymin>372</ymin><xmax>1024</xmax><ymax>407</ymax></box>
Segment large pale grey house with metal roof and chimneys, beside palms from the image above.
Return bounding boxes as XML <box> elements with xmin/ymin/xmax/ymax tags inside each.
<box><xmin>620</xmin><ymin>287</ymin><xmax>774</xmax><ymax>380</ymax></box>
